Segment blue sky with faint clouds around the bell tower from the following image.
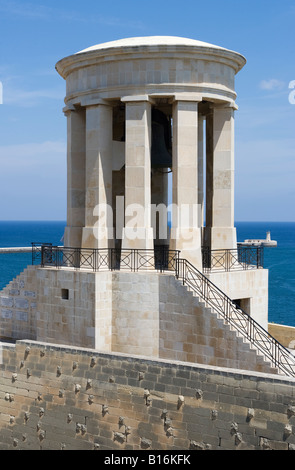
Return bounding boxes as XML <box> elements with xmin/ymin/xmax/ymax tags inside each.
<box><xmin>0</xmin><ymin>0</ymin><xmax>295</xmax><ymax>221</ymax></box>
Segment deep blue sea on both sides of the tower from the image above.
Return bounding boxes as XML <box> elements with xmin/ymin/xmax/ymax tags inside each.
<box><xmin>0</xmin><ymin>221</ymin><xmax>295</xmax><ymax>327</ymax></box>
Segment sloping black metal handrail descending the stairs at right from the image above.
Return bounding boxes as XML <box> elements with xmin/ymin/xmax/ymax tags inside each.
<box><xmin>177</xmin><ymin>258</ymin><xmax>295</xmax><ymax>377</ymax></box>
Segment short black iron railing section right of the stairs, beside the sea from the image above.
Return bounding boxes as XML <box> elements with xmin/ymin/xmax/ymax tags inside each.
<box><xmin>202</xmin><ymin>245</ymin><xmax>263</xmax><ymax>273</ymax></box>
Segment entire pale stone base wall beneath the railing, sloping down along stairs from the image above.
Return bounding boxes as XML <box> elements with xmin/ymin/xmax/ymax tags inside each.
<box><xmin>0</xmin><ymin>266</ymin><xmax>274</xmax><ymax>373</ymax></box>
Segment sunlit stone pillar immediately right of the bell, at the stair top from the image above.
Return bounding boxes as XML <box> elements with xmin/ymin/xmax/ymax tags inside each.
<box><xmin>170</xmin><ymin>98</ymin><xmax>202</xmax><ymax>268</ymax></box>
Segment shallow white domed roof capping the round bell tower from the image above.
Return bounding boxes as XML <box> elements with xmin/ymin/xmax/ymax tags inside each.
<box><xmin>77</xmin><ymin>36</ymin><xmax>232</xmax><ymax>54</ymax></box>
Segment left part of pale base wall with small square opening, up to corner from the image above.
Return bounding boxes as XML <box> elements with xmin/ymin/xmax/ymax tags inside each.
<box><xmin>0</xmin><ymin>266</ymin><xmax>112</xmax><ymax>351</ymax></box>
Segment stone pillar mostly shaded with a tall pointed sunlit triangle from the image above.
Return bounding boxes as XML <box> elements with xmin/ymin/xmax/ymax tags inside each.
<box><xmin>82</xmin><ymin>102</ymin><xmax>113</xmax><ymax>248</ymax></box>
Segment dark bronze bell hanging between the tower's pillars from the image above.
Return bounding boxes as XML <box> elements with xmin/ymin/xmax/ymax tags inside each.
<box><xmin>151</xmin><ymin>110</ymin><xmax>172</xmax><ymax>168</ymax></box>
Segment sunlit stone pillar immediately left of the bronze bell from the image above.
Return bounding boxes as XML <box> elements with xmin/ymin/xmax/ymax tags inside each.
<box><xmin>122</xmin><ymin>96</ymin><xmax>154</xmax><ymax>249</ymax></box>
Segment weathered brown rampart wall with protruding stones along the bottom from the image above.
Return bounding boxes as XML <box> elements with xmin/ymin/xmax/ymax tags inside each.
<box><xmin>0</xmin><ymin>341</ymin><xmax>295</xmax><ymax>451</ymax></box>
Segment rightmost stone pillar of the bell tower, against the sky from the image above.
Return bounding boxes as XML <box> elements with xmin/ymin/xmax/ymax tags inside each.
<box><xmin>205</xmin><ymin>106</ymin><xmax>237</xmax><ymax>250</ymax></box>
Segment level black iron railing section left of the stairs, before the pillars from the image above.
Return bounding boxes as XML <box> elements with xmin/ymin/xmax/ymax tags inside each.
<box><xmin>33</xmin><ymin>244</ymin><xmax>179</xmax><ymax>272</ymax></box>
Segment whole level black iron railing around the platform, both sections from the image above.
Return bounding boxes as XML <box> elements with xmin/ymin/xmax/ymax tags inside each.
<box><xmin>32</xmin><ymin>242</ymin><xmax>263</xmax><ymax>273</ymax></box>
